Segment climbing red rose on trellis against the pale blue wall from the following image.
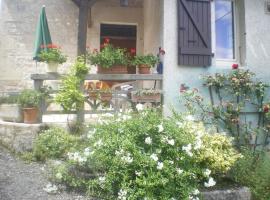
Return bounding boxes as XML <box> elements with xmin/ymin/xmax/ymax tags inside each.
<box><xmin>183</xmin><ymin>70</ymin><xmax>270</xmax><ymax>150</ymax></box>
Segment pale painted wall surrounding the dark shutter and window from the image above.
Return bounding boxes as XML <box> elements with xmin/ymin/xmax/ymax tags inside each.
<box><xmin>163</xmin><ymin>0</ymin><xmax>270</xmax><ymax>114</ymax></box>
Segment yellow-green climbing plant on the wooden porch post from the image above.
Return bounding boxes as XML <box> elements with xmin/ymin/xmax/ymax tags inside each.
<box><xmin>55</xmin><ymin>57</ymin><xmax>89</xmax><ymax>111</ymax></box>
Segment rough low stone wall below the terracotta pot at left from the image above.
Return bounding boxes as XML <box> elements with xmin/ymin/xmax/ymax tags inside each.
<box><xmin>0</xmin><ymin>121</ymin><xmax>43</xmax><ymax>153</ymax></box>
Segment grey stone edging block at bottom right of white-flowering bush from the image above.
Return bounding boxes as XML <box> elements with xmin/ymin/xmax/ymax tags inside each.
<box><xmin>203</xmin><ymin>187</ymin><xmax>251</xmax><ymax>200</ymax></box>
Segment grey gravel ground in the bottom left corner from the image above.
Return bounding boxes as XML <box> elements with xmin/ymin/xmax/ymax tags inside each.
<box><xmin>0</xmin><ymin>146</ymin><xmax>89</xmax><ymax>200</ymax></box>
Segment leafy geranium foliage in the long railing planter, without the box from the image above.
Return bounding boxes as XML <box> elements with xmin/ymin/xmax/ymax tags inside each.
<box><xmin>88</xmin><ymin>44</ymin><xmax>129</xmax><ymax>68</ymax></box>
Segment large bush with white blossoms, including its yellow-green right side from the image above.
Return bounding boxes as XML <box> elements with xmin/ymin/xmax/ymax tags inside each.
<box><xmin>53</xmin><ymin>110</ymin><xmax>240</xmax><ymax>200</ymax></box>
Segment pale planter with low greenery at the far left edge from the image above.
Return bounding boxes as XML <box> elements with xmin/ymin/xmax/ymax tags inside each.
<box><xmin>0</xmin><ymin>95</ymin><xmax>22</xmax><ymax>122</ymax></box>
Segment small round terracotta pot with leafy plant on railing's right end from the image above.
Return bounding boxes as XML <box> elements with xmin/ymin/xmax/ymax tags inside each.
<box><xmin>132</xmin><ymin>54</ymin><xmax>158</xmax><ymax>74</ymax></box>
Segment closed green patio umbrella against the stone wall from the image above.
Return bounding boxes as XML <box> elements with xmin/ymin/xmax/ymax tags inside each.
<box><xmin>33</xmin><ymin>6</ymin><xmax>52</xmax><ymax>61</ymax></box>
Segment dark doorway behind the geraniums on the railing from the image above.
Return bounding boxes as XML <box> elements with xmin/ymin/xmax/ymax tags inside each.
<box><xmin>100</xmin><ymin>24</ymin><xmax>137</xmax><ymax>74</ymax></box>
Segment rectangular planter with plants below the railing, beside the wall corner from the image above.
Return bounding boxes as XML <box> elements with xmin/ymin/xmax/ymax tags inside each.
<box><xmin>131</xmin><ymin>89</ymin><xmax>161</xmax><ymax>102</ymax></box>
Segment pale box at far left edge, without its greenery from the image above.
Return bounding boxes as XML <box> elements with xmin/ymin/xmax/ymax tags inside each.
<box><xmin>0</xmin><ymin>104</ymin><xmax>22</xmax><ymax>122</ymax></box>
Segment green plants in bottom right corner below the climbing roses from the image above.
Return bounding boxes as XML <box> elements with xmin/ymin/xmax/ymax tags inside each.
<box><xmin>230</xmin><ymin>150</ymin><xmax>270</xmax><ymax>200</ymax></box>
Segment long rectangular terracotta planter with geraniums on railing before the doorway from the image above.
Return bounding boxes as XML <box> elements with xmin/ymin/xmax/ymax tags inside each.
<box><xmin>88</xmin><ymin>43</ymin><xmax>128</xmax><ymax>74</ymax></box>
